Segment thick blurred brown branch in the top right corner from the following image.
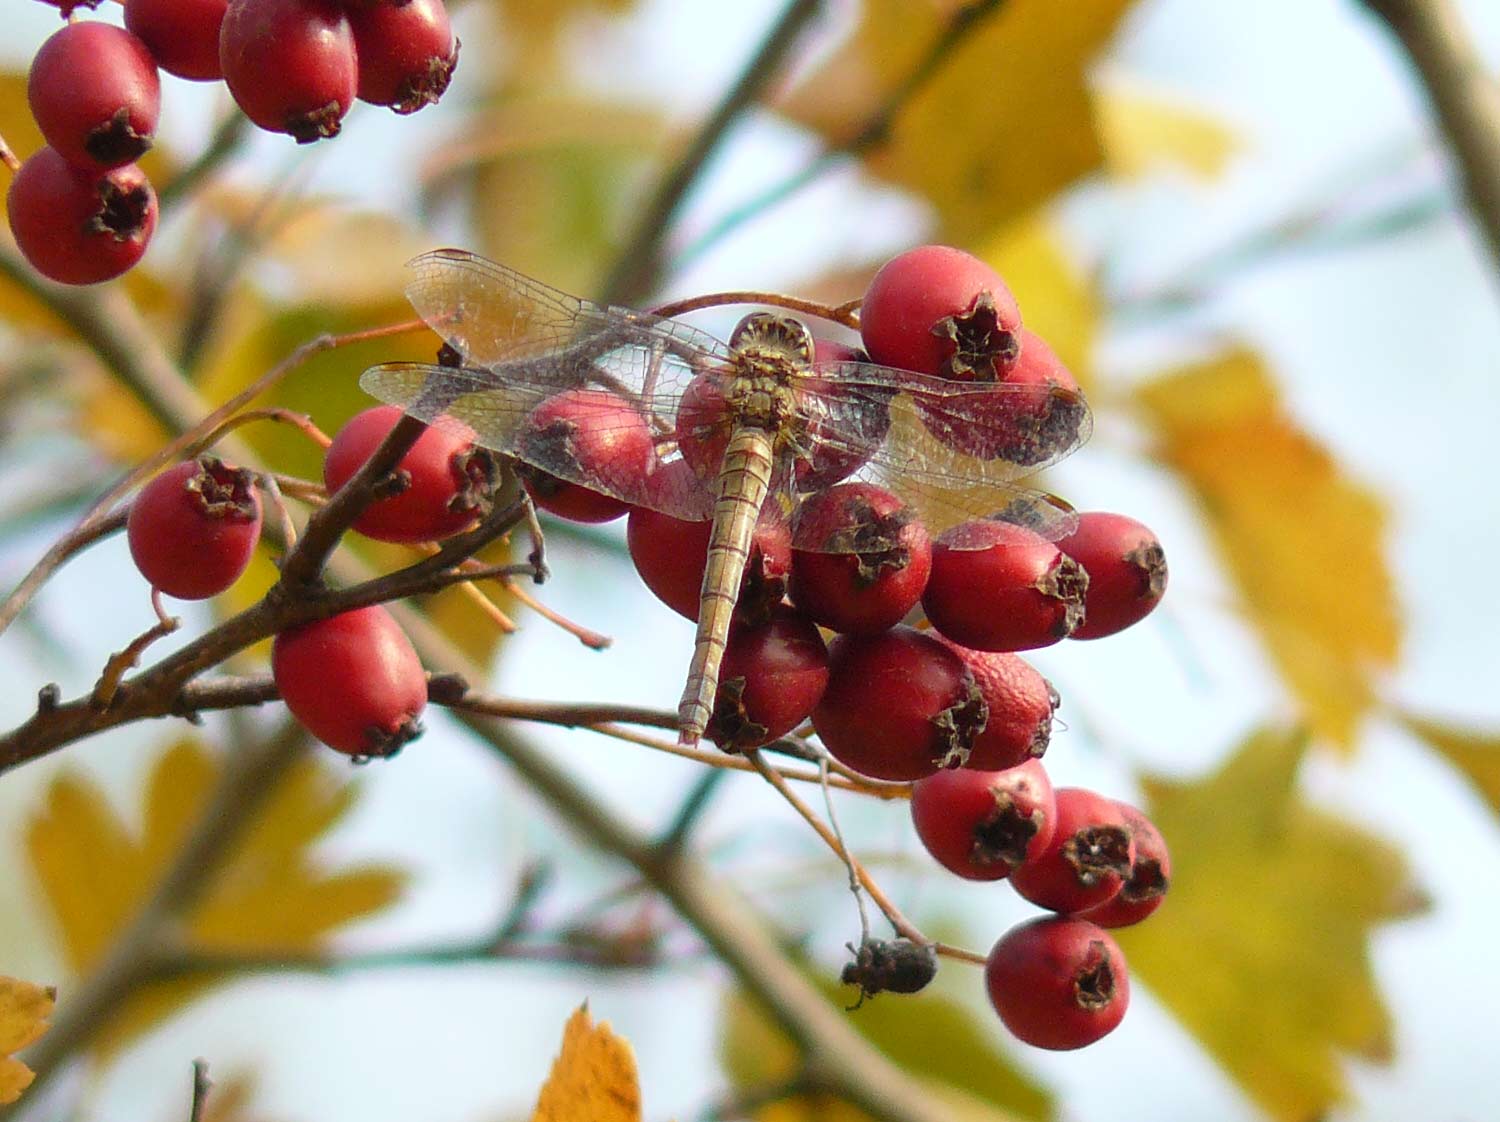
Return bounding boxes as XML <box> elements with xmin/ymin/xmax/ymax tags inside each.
<box><xmin>1365</xmin><ymin>0</ymin><xmax>1500</xmax><ymax>279</ymax></box>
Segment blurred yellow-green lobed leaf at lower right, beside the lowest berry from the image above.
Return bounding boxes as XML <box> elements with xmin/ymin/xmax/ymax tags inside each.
<box><xmin>1116</xmin><ymin>729</ymin><xmax>1422</xmax><ymax>1122</ymax></box>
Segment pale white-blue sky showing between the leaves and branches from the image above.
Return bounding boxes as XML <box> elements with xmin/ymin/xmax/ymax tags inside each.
<box><xmin>0</xmin><ymin>0</ymin><xmax>1500</xmax><ymax>1122</ymax></box>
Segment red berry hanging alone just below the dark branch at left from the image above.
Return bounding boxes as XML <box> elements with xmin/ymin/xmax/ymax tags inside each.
<box><xmin>272</xmin><ymin>605</ymin><xmax>428</xmax><ymax>759</ymax></box>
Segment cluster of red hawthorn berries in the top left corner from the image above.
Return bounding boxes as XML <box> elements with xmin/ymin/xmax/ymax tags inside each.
<box><xmin>6</xmin><ymin>0</ymin><xmax>459</xmax><ymax>285</ymax></box>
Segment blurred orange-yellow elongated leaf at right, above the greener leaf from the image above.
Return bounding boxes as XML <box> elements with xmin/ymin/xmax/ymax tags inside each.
<box><xmin>1137</xmin><ymin>351</ymin><xmax>1403</xmax><ymax>747</ymax></box>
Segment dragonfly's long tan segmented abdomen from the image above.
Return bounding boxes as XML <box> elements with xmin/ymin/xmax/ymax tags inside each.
<box><xmin>677</xmin><ymin>426</ymin><xmax>774</xmax><ymax>744</ymax></box>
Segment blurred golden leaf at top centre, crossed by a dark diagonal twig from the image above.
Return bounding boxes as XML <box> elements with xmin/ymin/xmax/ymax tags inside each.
<box><xmin>783</xmin><ymin>0</ymin><xmax>1131</xmax><ymax>245</ymax></box>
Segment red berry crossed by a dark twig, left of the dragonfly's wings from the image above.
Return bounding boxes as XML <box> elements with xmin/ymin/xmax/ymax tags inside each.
<box><xmin>323</xmin><ymin>405</ymin><xmax>498</xmax><ymax>542</ymax></box>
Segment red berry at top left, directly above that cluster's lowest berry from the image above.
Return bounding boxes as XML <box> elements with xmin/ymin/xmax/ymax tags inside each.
<box><xmin>26</xmin><ymin>20</ymin><xmax>162</xmax><ymax>171</ymax></box>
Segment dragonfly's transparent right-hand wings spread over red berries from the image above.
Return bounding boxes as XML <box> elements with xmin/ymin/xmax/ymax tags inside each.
<box><xmin>795</xmin><ymin>363</ymin><xmax>1092</xmax><ymax>549</ymax></box>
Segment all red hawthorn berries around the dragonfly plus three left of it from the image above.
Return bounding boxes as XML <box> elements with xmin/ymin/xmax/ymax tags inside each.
<box><xmin>128</xmin><ymin>246</ymin><xmax>1170</xmax><ymax>1049</ymax></box>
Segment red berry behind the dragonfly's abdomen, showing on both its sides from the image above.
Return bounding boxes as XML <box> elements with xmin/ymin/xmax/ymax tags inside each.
<box><xmin>626</xmin><ymin>459</ymin><xmax>792</xmax><ymax>623</ymax></box>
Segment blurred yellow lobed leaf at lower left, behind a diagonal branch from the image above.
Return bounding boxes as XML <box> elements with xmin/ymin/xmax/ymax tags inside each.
<box><xmin>26</xmin><ymin>740</ymin><xmax>405</xmax><ymax>1049</ymax></box>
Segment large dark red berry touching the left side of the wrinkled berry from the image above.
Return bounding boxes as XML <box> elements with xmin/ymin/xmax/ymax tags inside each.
<box><xmin>813</xmin><ymin>627</ymin><xmax>989</xmax><ymax>780</ymax></box>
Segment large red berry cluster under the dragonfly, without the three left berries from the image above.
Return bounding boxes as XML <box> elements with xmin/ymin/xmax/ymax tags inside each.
<box><xmin>516</xmin><ymin>246</ymin><xmax>1169</xmax><ymax>1049</ymax></box>
